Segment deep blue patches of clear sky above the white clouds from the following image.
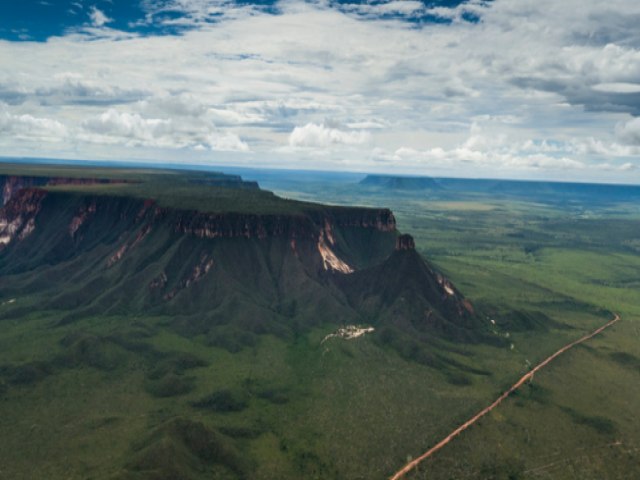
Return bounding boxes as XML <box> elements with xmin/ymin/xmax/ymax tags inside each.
<box><xmin>0</xmin><ymin>0</ymin><xmax>478</xmax><ymax>41</ymax></box>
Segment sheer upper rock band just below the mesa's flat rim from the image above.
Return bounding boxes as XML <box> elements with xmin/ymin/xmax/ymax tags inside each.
<box><xmin>0</xmin><ymin>188</ymin><xmax>396</xmax><ymax>273</ymax></box>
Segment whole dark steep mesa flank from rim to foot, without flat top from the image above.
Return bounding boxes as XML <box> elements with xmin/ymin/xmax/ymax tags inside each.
<box><xmin>0</xmin><ymin>178</ymin><xmax>484</xmax><ymax>348</ymax></box>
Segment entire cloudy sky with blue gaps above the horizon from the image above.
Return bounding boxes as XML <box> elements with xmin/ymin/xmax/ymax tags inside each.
<box><xmin>0</xmin><ymin>0</ymin><xmax>640</xmax><ymax>183</ymax></box>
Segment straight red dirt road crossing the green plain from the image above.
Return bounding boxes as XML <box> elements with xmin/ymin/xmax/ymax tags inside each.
<box><xmin>390</xmin><ymin>314</ymin><xmax>620</xmax><ymax>480</ymax></box>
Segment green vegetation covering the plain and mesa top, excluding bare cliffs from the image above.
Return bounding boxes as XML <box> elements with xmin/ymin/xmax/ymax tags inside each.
<box><xmin>0</xmin><ymin>167</ymin><xmax>640</xmax><ymax>480</ymax></box>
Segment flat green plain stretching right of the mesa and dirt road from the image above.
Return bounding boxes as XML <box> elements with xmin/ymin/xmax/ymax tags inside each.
<box><xmin>258</xmin><ymin>177</ymin><xmax>640</xmax><ymax>479</ymax></box>
